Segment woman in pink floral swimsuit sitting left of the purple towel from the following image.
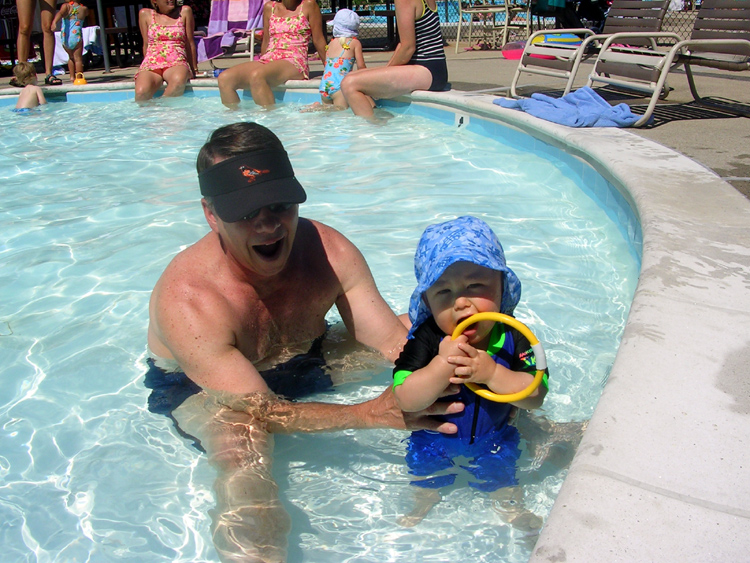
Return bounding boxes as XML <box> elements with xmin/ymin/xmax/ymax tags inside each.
<box><xmin>135</xmin><ymin>0</ymin><xmax>197</xmax><ymax>102</ymax></box>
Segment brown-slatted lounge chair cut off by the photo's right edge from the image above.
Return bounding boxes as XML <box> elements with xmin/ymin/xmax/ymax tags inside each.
<box><xmin>587</xmin><ymin>0</ymin><xmax>750</xmax><ymax>127</ymax></box>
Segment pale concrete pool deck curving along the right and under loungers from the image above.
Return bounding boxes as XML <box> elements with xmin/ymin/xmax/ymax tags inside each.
<box><xmin>4</xmin><ymin>47</ymin><xmax>750</xmax><ymax>563</ymax></box>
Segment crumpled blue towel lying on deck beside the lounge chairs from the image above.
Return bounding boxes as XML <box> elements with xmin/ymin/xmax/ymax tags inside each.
<box><xmin>493</xmin><ymin>86</ymin><xmax>640</xmax><ymax>127</ymax></box>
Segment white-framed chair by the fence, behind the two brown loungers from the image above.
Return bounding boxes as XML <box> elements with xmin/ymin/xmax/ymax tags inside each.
<box><xmin>456</xmin><ymin>0</ymin><xmax>531</xmax><ymax>53</ymax></box>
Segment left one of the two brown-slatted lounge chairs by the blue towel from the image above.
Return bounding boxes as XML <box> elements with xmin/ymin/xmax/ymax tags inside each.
<box><xmin>510</xmin><ymin>0</ymin><xmax>669</xmax><ymax>98</ymax></box>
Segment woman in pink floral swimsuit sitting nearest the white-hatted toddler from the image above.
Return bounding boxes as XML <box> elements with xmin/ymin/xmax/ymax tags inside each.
<box><xmin>214</xmin><ymin>0</ymin><xmax>326</xmax><ymax>108</ymax></box>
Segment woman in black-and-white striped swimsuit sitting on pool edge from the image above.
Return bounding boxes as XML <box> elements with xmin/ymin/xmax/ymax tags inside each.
<box><xmin>341</xmin><ymin>0</ymin><xmax>448</xmax><ymax>119</ymax></box>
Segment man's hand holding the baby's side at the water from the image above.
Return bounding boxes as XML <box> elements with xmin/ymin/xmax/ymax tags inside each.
<box><xmin>365</xmin><ymin>385</ymin><xmax>464</xmax><ymax>434</ymax></box>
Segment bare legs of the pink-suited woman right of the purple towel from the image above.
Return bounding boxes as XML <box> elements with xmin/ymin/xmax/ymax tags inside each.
<box><xmin>219</xmin><ymin>61</ymin><xmax>304</xmax><ymax>108</ymax></box>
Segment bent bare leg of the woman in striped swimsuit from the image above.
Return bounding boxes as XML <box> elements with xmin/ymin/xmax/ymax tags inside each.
<box><xmin>341</xmin><ymin>65</ymin><xmax>432</xmax><ymax>119</ymax></box>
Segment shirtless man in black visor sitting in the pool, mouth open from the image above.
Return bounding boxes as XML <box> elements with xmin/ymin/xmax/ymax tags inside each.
<box><xmin>147</xmin><ymin>123</ymin><xmax>463</xmax><ymax>561</ymax></box>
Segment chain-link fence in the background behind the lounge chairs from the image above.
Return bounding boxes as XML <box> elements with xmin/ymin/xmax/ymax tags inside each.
<box><xmin>322</xmin><ymin>0</ymin><xmax>700</xmax><ymax>50</ymax></box>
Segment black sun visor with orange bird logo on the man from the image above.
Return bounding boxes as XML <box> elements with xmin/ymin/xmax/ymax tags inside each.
<box><xmin>198</xmin><ymin>148</ymin><xmax>307</xmax><ymax>223</ymax></box>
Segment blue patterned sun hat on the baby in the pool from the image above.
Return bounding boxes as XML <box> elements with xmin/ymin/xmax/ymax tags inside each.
<box><xmin>409</xmin><ymin>216</ymin><xmax>521</xmax><ymax>338</ymax></box>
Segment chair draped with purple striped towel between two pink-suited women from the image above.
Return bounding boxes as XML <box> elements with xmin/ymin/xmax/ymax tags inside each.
<box><xmin>195</xmin><ymin>0</ymin><xmax>263</xmax><ymax>68</ymax></box>
